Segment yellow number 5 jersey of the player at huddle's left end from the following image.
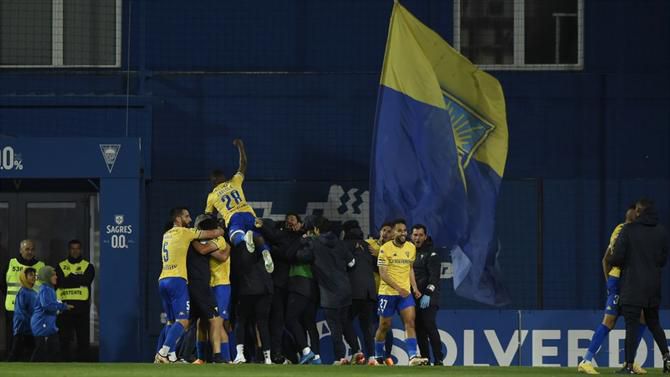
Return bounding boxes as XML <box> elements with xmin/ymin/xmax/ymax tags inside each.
<box><xmin>158</xmin><ymin>226</ymin><xmax>200</xmax><ymax>281</ymax></box>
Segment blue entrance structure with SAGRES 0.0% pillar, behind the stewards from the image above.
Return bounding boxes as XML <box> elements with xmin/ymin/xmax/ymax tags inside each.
<box><xmin>0</xmin><ymin>137</ymin><xmax>144</xmax><ymax>361</ymax></box>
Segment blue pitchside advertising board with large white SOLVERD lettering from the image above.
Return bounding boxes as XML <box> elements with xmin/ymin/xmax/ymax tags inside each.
<box><xmin>317</xmin><ymin>310</ymin><xmax>670</xmax><ymax>368</ymax></box>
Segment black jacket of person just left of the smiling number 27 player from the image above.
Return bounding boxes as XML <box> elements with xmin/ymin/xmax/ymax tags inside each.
<box><xmin>344</xmin><ymin>240</ymin><xmax>377</xmax><ymax>302</ymax></box>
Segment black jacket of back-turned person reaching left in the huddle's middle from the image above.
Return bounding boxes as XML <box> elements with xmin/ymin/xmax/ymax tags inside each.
<box><xmin>296</xmin><ymin>232</ymin><xmax>354</xmax><ymax>309</ymax></box>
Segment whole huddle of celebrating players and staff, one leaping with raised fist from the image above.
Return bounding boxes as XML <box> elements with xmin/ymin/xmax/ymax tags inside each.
<box><xmin>154</xmin><ymin>139</ymin><xmax>442</xmax><ymax>366</ymax></box>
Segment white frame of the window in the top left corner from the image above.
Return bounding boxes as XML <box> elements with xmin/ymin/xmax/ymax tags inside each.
<box><xmin>0</xmin><ymin>0</ymin><xmax>123</xmax><ymax>69</ymax></box>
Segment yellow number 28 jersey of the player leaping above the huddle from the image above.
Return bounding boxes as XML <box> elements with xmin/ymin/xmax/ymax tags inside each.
<box><xmin>205</xmin><ymin>172</ymin><xmax>256</xmax><ymax>226</ymax></box>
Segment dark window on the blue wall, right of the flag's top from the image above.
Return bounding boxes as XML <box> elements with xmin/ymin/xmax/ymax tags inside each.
<box><xmin>454</xmin><ymin>0</ymin><xmax>584</xmax><ymax>70</ymax></box>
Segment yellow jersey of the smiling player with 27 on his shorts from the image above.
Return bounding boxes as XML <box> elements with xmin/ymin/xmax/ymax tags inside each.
<box><xmin>377</xmin><ymin>241</ymin><xmax>416</xmax><ymax>296</ymax></box>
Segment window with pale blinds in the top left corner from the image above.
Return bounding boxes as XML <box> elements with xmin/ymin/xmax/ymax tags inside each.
<box><xmin>0</xmin><ymin>0</ymin><xmax>122</xmax><ymax>68</ymax></box>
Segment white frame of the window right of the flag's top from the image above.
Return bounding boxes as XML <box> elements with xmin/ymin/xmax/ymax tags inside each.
<box><xmin>454</xmin><ymin>0</ymin><xmax>584</xmax><ymax>71</ymax></box>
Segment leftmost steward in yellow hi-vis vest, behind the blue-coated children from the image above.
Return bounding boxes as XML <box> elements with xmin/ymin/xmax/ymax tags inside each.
<box><xmin>5</xmin><ymin>239</ymin><xmax>44</xmax><ymax>358</ymax></box>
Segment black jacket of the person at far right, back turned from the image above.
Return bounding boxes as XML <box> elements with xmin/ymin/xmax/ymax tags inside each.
<box><xmin>608</xmin><ymin>208</ymin><xmax>668</xmax><ymax>308</ymax></box>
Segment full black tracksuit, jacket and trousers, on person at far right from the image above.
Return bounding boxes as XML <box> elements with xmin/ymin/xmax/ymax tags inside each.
<box><xmin>608</xmin><ymin>207</ymin><xmax>668</xmax><ymax>365</ymax></box>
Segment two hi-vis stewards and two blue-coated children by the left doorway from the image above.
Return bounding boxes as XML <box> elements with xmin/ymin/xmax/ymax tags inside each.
<box><xmin>4</xmin><ymin>239</ymin><xmax>95</xmax><ymax>361</ymax></box>
